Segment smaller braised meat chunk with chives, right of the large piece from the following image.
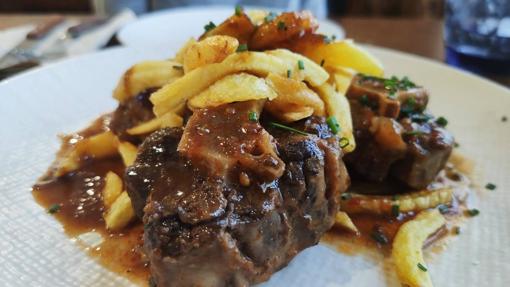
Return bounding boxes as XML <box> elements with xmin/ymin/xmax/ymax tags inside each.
<box><xmin>346</xmin><ymin>75</ymin><xmax>454</xmax><ymax>189</ymax></box>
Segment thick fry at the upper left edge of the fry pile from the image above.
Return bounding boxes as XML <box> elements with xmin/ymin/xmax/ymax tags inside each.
<box><xmin>113</xmin><ymin>61</ymin><xmax>183</xmax><ymax>103</ymax></box>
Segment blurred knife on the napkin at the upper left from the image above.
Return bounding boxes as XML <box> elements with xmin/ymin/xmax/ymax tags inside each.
<box><xmin>0</xmin><ymin>15</ymin><xmax>64</xmax><ymax>68</ymax></box>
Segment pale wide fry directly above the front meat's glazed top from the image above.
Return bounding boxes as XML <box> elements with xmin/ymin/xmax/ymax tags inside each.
<box><xmin>188</xmin><ymin>73</ymin><xmax>277</xmax><ymax>109</ymax></box>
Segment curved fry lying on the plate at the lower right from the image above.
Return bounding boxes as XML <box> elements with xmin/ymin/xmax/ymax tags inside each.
<box><xmin>392</xmin><ymin>209</ymin><xmax>446</xmax><ymax>287</ymax></box>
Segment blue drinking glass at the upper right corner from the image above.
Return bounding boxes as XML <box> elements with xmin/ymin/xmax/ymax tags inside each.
<box><xmin>444</xmin><ymin>0</ymin><xmax>510</xmax><ymax>75</ymax></box>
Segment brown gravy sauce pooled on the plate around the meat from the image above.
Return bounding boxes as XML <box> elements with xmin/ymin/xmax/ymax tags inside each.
<box><xmin>32</xmin><ymin>115</ymin><xmax>472</xmax><ymax>286</ymax></box>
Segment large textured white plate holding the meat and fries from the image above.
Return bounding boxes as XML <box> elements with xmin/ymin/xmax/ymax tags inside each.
<box><xmin>0</xmin><ymin>45</ymin><xmax>510</xmax><ymax>287</ymax></box>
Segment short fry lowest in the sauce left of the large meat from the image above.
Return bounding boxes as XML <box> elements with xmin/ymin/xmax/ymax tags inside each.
<box><xmin>104</xmin><ymin>191</ymin><xmax>135</xmax><ymax>231</ymax></box>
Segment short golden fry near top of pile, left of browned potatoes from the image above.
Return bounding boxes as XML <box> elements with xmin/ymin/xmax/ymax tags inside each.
<box><xmin>183</xmin><ymin>35</ymin><xmax>239</xmax><ymax>73</ymax></box>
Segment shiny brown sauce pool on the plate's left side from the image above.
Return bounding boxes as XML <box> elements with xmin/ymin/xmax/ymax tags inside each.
<box><xmin>32</xmin><ymin>118</ymin><xmax>149</xmax><ymax>285</ymax></box>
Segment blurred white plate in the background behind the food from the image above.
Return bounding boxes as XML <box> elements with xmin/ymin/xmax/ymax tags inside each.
<box><xmin>117</xmin><ymin>6</ymin><xmax>345</xmax><ymax>51</ymax></box>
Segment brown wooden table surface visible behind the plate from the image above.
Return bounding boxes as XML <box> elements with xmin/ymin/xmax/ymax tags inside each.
<box><xmin>0</xmin><ymin>14</ymin><xmax>510</xmax><ymax>86</ymax></box>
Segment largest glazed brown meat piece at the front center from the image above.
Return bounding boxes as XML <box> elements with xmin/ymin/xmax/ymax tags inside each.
<box><xmin>126</xmin><ymin>101</ymin><xmax>349</xmax><ymax>286</ymax></box>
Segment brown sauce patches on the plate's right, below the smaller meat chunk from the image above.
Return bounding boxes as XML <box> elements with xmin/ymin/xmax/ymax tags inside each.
<box><xmin>322</xmin><ymin>153</ymin><xmax>474</xmax><ymax>255</ymax></box>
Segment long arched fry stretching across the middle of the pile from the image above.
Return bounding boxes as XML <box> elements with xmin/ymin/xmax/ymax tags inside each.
<box><xmin>150</xmin><ymin>52</ymin><xmax>328</xmax><ymax>116</ymax></box>
